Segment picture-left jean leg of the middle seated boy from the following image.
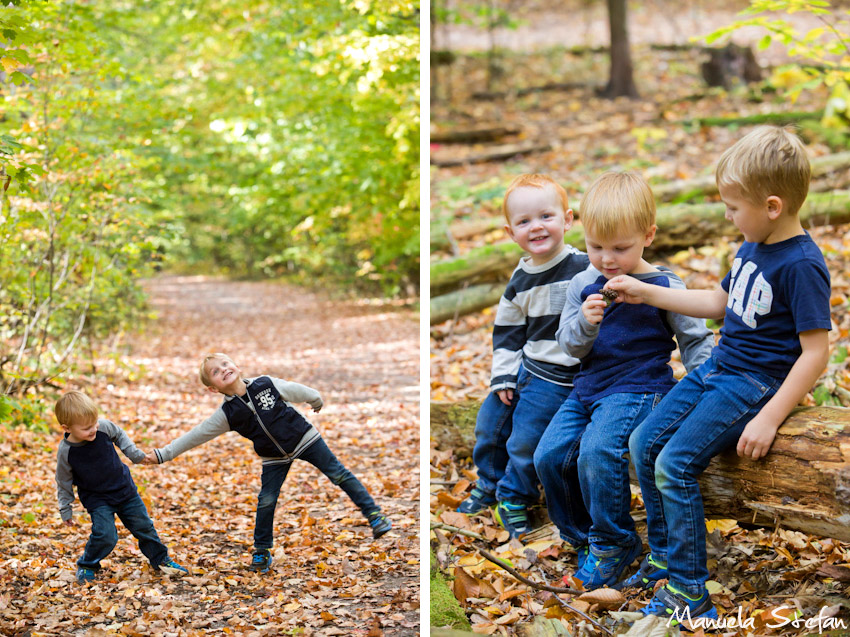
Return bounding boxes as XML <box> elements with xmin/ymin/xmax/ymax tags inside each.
<box><xmin>534</xmin><ymin>398</ymin><xmax>590</xmax><ymax>547</ymax></box>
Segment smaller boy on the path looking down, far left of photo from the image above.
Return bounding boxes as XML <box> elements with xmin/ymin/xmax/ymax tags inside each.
<box><xmin>53</xmin><ymin>391</ymin><xmax>189</xmax><ymax>584</ymax></box>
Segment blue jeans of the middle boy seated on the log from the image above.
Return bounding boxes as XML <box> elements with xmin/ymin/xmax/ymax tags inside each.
<box><xmin>534</xmin><ymin>393</ymin><xmax>661</xmax><ymax>547</ymax></box>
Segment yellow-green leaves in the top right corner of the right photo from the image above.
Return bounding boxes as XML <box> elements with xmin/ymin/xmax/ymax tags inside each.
<box><xmin>706</xmin><ymin>0</ymin><xmax>850</xmax><ymax>124</ymax></box>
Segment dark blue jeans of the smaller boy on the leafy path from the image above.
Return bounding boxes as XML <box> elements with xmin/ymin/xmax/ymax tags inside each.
<box><xmin>77</xmin><ymin>493</ymin><xmax>168</xmax><ymax>570</ymax></box>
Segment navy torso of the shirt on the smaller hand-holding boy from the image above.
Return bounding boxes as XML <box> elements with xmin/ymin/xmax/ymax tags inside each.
<box><xmin>65</xmin><ymin>431</ymin><xmax>136</xmax><ymax>511</ymax></box>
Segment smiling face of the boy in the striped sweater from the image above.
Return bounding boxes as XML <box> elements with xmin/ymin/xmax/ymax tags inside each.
<box><xmin>505</xmin><ymin>185</ymin><xmax>573</xmax><ymax>265</ymax></box>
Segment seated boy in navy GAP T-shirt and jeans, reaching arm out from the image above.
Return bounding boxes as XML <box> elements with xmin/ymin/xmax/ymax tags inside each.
<box><xmin>608</xmin><ymin>126</ymin><xmax>831</xmax><ymax>624</ymax></box>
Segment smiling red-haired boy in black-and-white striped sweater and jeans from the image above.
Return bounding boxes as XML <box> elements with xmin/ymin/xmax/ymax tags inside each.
<box><xmin>458</xmin><ymin>174</ymin><xmax>590</xmax><ymax>537</ymax></box>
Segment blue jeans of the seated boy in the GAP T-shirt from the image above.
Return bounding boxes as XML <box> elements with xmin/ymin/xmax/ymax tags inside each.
<box><xmin>629</xmin><ymin>356</ymin><xmax>782</xmax><ymax>596</ymax></box>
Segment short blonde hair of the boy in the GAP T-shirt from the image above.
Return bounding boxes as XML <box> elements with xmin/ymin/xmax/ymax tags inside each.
<box><xmin>715</xmin><ymin>126</ymin><xmax>812</xmax><ymax>214</ymax></box>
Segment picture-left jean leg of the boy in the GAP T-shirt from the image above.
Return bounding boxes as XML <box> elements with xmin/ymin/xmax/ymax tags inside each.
<box><xmin>629</xmin><ymin>358</ymin><xmax>715</xmax><ymax>562</ymax></box>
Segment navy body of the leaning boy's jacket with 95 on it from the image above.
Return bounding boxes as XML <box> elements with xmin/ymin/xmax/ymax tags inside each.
<box><xmin>221</xmin><ymin>376</ymin><xmax>312</xmax><ymax>458</ymax></box>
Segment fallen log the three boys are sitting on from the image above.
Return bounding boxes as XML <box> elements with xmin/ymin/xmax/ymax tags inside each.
<box><xmin>431</xmin><ymin>400</ymin><xmax>850</xmax><ymax>542</ymax></box>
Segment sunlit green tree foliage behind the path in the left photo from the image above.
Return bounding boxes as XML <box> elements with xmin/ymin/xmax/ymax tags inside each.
<box><xmin>0</xmin><ymin>0</ymin><xmax>420</xmax><ymax>393</ymax></box>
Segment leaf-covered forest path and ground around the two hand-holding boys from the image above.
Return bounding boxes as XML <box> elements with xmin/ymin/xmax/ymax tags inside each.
<box><xmin>0</xmin><ymin>277</ymin><xmax>420</xmax><ymax>636</ymax></box>
